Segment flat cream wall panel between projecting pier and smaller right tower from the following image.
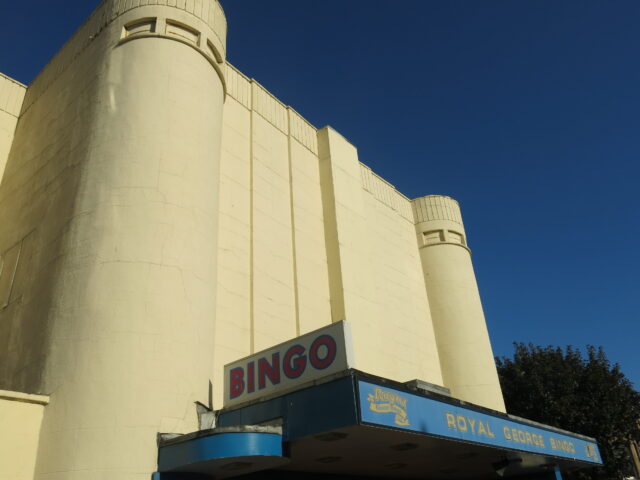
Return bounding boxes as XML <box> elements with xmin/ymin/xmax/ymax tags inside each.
<box><xmin>360</xmin><ymin>164</ymin><xmax>442</xmax><ymax>385</ymax></box>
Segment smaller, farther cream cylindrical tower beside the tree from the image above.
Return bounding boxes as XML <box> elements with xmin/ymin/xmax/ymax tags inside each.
<box><xmin>412</xmin><ymin>195</ymin><xmax>505</xmax><ymax>411</ymax></box>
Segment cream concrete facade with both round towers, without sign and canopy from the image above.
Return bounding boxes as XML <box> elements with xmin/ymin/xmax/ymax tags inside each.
<box><xmin>0</xmin><ymin>0</ymin><xmax>504</xmax><ymax>480</ymax></box>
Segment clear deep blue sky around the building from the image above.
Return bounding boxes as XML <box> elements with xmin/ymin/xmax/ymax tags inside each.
<box><xmin>0</xmin><ymin>0</ymin><xmax>640</xmax><ymax>389</ymax></box>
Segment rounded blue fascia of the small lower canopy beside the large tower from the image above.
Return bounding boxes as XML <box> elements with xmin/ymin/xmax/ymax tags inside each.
<box><xmin>158</xmin><ymin>432</ymin><xmax>282</xmax><ymax>472</ymax></box>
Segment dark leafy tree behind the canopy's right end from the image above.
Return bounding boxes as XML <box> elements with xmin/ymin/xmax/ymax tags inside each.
<box><xmin>496</xmin><ymin>343</ymin><xmax>640</xmax><ymax>480</ymax></box>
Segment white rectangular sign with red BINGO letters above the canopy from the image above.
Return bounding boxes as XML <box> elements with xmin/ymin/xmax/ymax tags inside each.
<box><xmin>224</xmin><ymin>321</ymin><xmax>353</xmax><ymax>408</ymax></box>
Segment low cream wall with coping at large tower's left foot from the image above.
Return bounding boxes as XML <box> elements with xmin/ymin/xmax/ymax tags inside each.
<box><xmin>0</xmin><ymin>390</ymin><xmax>49</xmax><ymax>480</ymax></box>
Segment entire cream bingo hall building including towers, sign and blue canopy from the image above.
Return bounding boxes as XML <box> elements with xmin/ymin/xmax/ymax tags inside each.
<box><xmin>0</xmin><ymin>0</ymin><xmax>600</xmax><ymax>480</ymax></box>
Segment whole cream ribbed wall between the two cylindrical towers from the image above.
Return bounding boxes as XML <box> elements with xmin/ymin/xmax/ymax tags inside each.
<box><xmin>214</xmin><ymin>87</ymin><xmax>442</xmax><ymax>394</ymax></box>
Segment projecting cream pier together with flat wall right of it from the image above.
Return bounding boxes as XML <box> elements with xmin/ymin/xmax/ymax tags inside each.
<box><xmin>318</xmin><ymin>127</ymin><xmax>442</xmax><ymax>385</ymax></box>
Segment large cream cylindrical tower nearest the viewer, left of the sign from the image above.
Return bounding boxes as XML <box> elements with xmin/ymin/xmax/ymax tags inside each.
<box><xmin>0</xmin><ymin>0</ymin><xmax>226</xmax><ymax>480</ymax></box>
